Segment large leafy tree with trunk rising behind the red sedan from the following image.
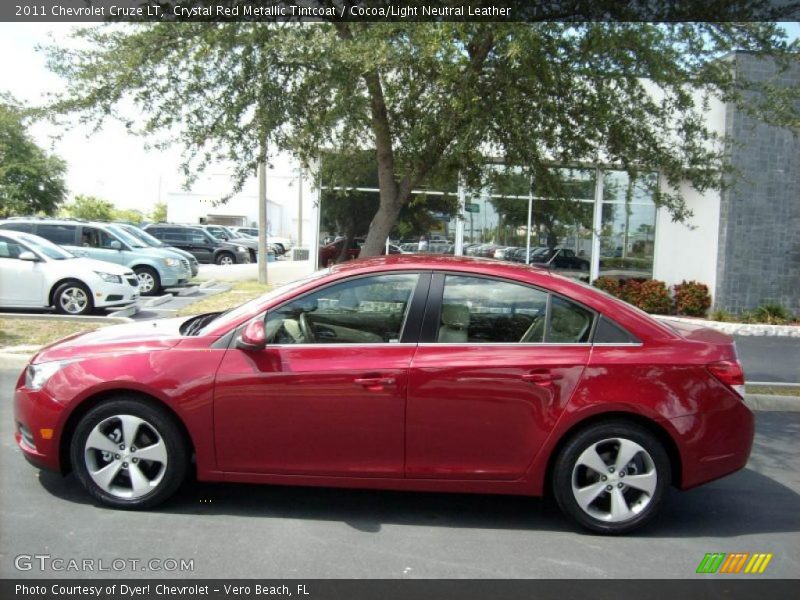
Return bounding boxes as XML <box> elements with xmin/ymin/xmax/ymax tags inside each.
<box><xmin>50</xmin><ymin>7</ymin><xmax>798</xmax><ymax>256</ymax></box>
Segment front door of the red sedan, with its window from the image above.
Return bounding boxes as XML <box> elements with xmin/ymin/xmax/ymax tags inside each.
<box><xmin>214</xmin><ymin>272</ymin><xmax>430</xmax><ymax>478</ymax></box>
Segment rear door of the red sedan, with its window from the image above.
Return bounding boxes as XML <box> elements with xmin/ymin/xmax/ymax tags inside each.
<box><xmin>406</xmin><ymin>273</ymin><xmax>594</xmax><ymax>480</ymax></box>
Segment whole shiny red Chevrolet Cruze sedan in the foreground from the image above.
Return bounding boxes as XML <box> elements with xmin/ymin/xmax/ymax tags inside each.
<box><xmin>15</xmin><ymin>256</ymin><xmax>754</xmax><ymax>533</ymax></box>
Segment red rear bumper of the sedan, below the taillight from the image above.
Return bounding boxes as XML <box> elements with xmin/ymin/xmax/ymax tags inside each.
<box><xmin>669</xmin><ymin>401</ymin><xmax>755</xmax><ymax>490</ymax></box>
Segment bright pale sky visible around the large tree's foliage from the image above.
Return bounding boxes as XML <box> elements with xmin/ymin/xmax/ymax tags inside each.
<box><xmin>0</xmin><ymin>23</ymin><xmax>800</xmax><ymax>212</ymax></box>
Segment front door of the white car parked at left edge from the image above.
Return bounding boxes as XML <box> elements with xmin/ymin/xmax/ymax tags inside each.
<box><xmin>0</xmin><ymin>235</ymin><xmax>48</xmax><ymax>307</ymax></box>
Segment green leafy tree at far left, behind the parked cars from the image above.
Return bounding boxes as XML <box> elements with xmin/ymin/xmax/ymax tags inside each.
<box><xmin>0</xmin><ymin>96</ymin><xmax>67</xmax><ymax>217</ymax></box>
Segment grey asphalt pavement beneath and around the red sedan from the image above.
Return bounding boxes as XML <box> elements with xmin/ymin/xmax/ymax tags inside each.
<box><xmin>0</xmin><ymin>365</ymin><xmax>800</xmax><ymax>579</ymax></box>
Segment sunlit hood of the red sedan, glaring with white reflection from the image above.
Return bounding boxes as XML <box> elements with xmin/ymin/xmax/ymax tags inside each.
<box><xmin>31</xmin><ymin>317</ymin><xmax>188</xmax><ymax>363</ymax></box>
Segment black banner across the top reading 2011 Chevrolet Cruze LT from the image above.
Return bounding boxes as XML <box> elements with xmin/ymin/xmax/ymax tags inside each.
<box><xmin>0</xmin><ymin>0</ymin><xmax>800</xmax><ymax>23</ymax></box>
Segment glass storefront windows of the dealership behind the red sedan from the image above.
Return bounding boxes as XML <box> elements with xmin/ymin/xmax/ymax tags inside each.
<box><xmin>320</xmin><ymin>153</ymin><xmax>658</xmax><ymax>281</ymax></box>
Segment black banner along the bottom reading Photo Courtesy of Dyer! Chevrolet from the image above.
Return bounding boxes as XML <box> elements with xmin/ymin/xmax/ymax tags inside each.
<box><xmin>0</xmin><ymin>576</ymin><xmax>797</xmax><ymax>600</ymax></box>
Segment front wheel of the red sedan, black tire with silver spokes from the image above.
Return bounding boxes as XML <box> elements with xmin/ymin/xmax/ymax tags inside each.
<box><xmin>70</xmin><ymin>394</ymin><xmax>189</xmax><ymax>509</ymax></box>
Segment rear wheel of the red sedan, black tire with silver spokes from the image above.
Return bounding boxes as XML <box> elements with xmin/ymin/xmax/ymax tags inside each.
<box><xmin>552</xmin><ymin>421</ymin><xmax>671</xmax><ymax>535</ymax></box>
